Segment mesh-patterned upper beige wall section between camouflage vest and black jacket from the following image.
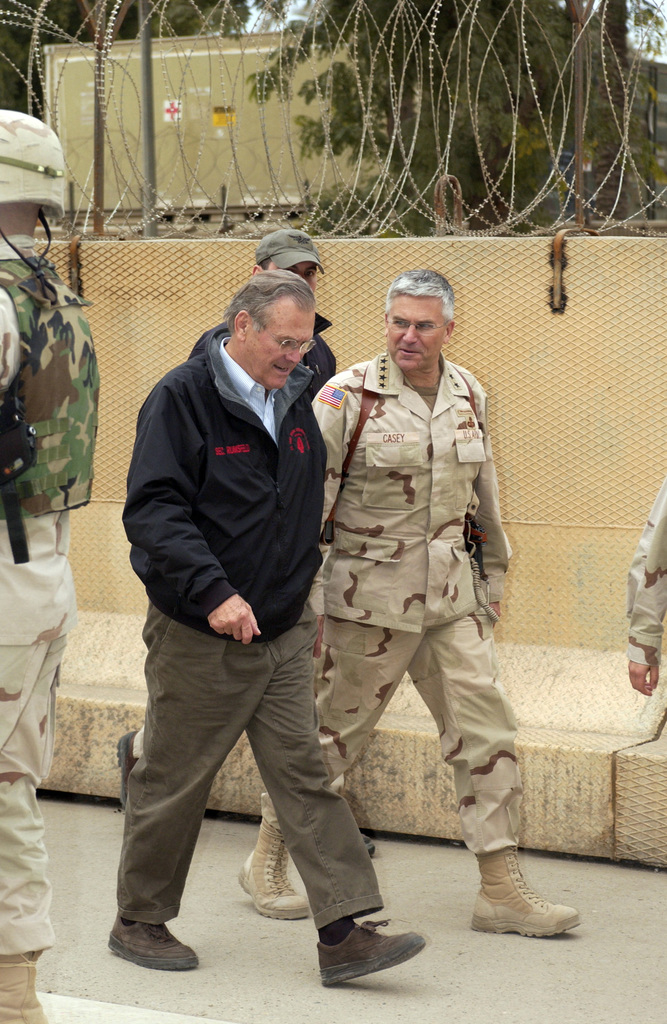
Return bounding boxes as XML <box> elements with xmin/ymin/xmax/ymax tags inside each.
<box><xmin>49</xmin><ymin>241</ymin><xmax>256</xmax><ymax>512</ymax></box>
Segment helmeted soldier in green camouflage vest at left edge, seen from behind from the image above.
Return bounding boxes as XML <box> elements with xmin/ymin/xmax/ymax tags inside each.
<box><xmin>0</xmin><ymin>111</ymin><xmax>98</xmax><ymax>1024</ymax></box>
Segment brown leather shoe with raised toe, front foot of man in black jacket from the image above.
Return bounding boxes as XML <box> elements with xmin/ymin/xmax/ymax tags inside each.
<box><xmin>318</xmin><ymin>921</ymin><xmax>426</xmax><ymax>985</ymax></box>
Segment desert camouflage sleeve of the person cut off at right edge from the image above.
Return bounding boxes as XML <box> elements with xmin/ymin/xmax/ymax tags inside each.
<box><xmin>627</xmin><ymin>479</ymin><xmax>667</xmax><ymax>665</ymax></box>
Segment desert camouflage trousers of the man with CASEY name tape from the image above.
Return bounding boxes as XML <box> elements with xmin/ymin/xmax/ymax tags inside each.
<box><xmin>266</xmin><ymin>612</ymin><xmax>524</xmax><ymax>853</ymax></box>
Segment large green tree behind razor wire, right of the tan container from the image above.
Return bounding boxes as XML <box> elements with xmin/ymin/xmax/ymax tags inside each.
<box><xmin>257</xmin><ymin>0</ymin><xmax>664</xmax><ymax>233</ymax></box>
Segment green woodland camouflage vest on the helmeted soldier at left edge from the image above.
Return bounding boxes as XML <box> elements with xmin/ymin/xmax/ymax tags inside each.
<box><xmin>0</xmin><ymin>259</ymin><xmax>99</xmax><ymax>519</ymax></box>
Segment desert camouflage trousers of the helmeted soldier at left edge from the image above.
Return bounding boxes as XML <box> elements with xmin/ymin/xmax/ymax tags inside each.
<box><xmin>0</xmin><ymin>637</ymin><xmax>67</xmax><ymax>955</ymax></box>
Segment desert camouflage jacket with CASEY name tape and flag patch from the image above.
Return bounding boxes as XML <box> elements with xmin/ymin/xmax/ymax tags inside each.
<box><xmin>311</xmin><ymin>353</ymin><xmax>509</xmax><ymax>632</ymax></box>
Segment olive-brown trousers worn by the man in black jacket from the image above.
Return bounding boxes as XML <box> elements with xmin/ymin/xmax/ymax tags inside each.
<box><xmin>118</xmin><ymin>606</ymin><xmax>382</xmax><ymax>928</ymax></box>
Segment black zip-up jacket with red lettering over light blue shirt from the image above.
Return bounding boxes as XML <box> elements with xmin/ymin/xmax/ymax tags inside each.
<box><xmin>123</xmin><ymin>335</ymin><xmax>326</xmax><ymax>642</ymax></box>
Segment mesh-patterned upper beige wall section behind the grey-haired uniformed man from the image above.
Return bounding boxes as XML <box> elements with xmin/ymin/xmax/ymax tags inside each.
<box><xmin>322</xmin><ymin>238</ymin><xmax>667</xmax><ymax>529</ymax></box>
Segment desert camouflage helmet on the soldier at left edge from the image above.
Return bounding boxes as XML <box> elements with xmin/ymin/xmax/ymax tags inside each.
<box><xmin>0</xmin><ymin>110</ymin><xmax>65</xmax><ymax>217</ymax></box>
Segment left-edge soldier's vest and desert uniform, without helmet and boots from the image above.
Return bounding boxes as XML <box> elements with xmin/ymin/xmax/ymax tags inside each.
<box><xmin>0</xmin><ymin>249</ymin><xmax>98</xmax><ymax>955</ymax></box>
